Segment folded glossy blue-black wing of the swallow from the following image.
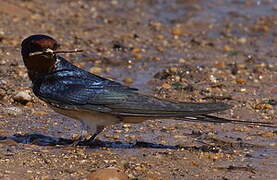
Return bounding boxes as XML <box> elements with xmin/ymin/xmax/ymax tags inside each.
<box><xmin>34</xmin><ymin>70</ymin><xmax>230</xmax><ymax>117</ymax></box>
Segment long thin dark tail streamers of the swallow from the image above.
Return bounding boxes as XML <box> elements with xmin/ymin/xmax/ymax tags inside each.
<box><xmin>176</xmin><ymin>114</ymin><xmax>277</xmax><ymax>128</ymax></box>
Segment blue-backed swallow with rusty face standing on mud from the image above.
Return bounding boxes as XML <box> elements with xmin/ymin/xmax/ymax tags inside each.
<box><xmin>21</xmin><ymin>35</ymin><xmax>274</xmax><ymax>144</ymax></box>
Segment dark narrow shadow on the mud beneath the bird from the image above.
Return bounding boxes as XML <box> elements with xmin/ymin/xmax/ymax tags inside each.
<box><xmin>0</xmin><ymin>134</ymin><xmax>219</xmax><ymax>153</ymax></box>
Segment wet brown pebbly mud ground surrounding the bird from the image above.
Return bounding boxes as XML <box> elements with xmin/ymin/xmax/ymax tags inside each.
<box><xmin>0</xmin><ymin>0</ymin><xmax>277</xmax><ymax>180</ymax></box>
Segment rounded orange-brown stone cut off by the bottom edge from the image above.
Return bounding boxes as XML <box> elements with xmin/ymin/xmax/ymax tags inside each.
<box><xmin>87</xmin><ymin>168</ymin><xmax>129</xmax><ymax>180</ymax></box>
